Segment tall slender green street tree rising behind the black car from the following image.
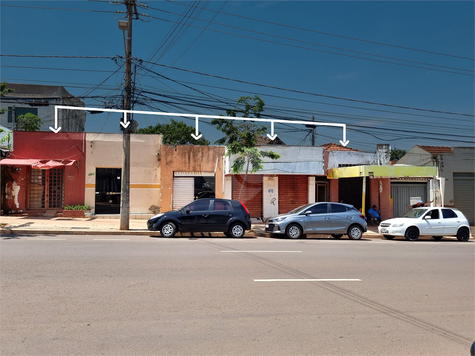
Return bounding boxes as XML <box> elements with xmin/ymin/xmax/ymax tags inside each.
<box><xmin>211</xmin><ymin>95</ymin><xmax>280</xmax><ymax>200</ymax></box>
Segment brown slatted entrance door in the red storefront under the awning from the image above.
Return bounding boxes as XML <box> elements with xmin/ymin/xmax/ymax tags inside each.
<box><xmin>29</xmin><ymin>168</ymin><xmax>64</xmax><ymax>209</ymax></box>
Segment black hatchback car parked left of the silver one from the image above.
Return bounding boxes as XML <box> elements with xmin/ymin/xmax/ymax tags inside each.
<box><xmin>147</xmin><ymin>198</ymin><xmax>251</xmax><ymax>238</ymax></box>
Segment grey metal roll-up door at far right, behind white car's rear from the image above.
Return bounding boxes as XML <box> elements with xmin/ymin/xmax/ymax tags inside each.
<box><xmin>454</xmin><ymin>173</ymin><xmax>475</xmax><ymax>225</ymax></box>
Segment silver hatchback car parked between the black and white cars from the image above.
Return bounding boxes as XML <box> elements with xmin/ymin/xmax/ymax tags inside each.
<box><xmin>266</xmin><ymin>202</ymin><xmax>368</xmax><ymax>240</ymax></box>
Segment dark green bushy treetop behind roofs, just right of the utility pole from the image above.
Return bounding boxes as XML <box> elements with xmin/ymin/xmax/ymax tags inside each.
<box><xmin>137</xmin><ymin>119</ymin><xmax>210</xmax><ymax>146</ymax></box>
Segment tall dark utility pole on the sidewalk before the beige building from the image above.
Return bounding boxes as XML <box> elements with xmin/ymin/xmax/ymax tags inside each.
<box><xmin>119</xmin><ymin>0</ymin><xmax>138</xmax><ymax>230</ymax></box>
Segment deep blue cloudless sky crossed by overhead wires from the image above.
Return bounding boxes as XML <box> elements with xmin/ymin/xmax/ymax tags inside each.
<box><xmin>0</xmin><ymin>0</ymin><xmax>475</xmax><ymax>152</ymax></box>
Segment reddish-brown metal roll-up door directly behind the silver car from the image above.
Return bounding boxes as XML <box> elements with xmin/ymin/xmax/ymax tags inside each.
<box><xmin>279</xmin><ymin>175</ymin><xmax>308</xmax><ymax>214</ymax></box>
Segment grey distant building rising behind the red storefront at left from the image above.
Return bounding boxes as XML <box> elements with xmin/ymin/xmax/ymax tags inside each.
<box><xmin>0</xmin><ymin>83</ymin><xmax>86</xmax><ymax>132</ymax></box>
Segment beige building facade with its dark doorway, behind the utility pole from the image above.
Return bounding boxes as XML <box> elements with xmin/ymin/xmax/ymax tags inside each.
<box><xmin>85</xmin><ymin>133</ymin><xmax>162</xmax><ymax>218</ymax></box>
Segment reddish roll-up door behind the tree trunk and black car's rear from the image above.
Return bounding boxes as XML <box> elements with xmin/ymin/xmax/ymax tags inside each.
<box><xmin>233</xmin><ymin>174</ymin><xmax>262</xmax><ymax>218</ymax></box>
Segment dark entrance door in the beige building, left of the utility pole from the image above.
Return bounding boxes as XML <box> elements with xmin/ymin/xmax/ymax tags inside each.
<box><xmin>95</xmin><ymin>168</ymin><xmax>122</xmax><ymax>214</ymax></box>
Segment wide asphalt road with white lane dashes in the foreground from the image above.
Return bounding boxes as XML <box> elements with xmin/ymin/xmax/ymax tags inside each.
<box><xmin>0</xmin><ymin>235</ymin><xmax>475</xmax><ymax>356</ymax></box>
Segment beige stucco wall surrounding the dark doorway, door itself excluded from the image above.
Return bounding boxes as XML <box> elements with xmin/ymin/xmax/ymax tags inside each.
<box><xmin>85</xmin><ymin>133</ymin><xmax>162</xmax><ymax>214</ymax></box>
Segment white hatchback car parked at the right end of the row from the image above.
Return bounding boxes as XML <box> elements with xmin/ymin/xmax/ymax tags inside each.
<box><xmin>378</xmin><ymin>207</ymin><xmax>470</xmax><ymax>241</ymax></box>
